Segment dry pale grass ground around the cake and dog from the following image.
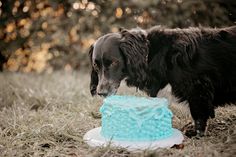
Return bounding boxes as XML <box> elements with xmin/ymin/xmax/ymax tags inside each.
<box><xmin>0</xmin><ymin>72</ymin><xmax>236</xmax><ymax>157</ymax></box>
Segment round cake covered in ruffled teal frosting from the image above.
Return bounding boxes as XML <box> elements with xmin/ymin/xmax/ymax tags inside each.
<box><xmin>100</xmin><ymin>95</ymin><xmax>173</xmax><ymax>141</ymax></box>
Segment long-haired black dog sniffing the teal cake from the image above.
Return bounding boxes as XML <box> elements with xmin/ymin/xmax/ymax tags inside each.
<box><xmin>89</xmin><ymin>26</ymin><xmax>236</xmax><ymax>136</ymax></box>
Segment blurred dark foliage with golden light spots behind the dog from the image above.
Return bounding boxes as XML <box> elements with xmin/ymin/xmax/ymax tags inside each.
<box><xmin>0</xmin><ymin>0</ymin><xmax>236</xmax><ymax>72</ymax></box>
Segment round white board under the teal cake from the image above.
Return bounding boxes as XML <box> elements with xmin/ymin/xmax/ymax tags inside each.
<box><xmin>84</xmin><ymin>127</ymin><xmax>184</xmax><ymax>151</ymax></box>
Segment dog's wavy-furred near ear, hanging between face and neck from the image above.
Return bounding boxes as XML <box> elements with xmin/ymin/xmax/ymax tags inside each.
<box><xmin>120</xmin><ymin>29</ymin><xmax>148</xmax><ymax>89</ymax></box>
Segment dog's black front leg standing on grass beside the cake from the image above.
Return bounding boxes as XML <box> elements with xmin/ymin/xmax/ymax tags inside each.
<box><xmin>185</xmin><ymin>77</ymin><xmax>214</xmax><ymax>136</ymax></box>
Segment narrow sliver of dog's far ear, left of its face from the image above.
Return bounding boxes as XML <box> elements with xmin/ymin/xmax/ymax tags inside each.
<box><xmin>89</xmin><ymin>45</ymin><xmax>98</xmax><ymax>96</ymax></box>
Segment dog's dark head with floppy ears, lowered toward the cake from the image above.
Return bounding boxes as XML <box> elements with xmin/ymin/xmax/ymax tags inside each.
<box><xmin>89</xmin><ymin>29</ymin><xmax>148</xmax><ymax>96</ymax></box>
